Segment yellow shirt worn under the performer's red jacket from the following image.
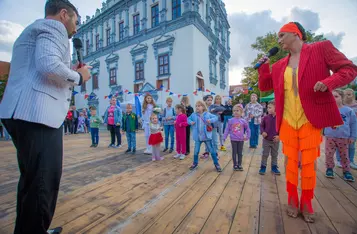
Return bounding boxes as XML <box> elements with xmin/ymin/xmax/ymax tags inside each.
<box><xmin>283</xmin><ymin>67</ymin><xmax>308</xmax><ymax>129</ymax></box>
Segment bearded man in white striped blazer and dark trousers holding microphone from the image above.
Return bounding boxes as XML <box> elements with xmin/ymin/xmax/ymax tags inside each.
<box><xmin>0</xmin><ymin>0</ymin><xmax>90</xmax><ymax>234</ymax></box>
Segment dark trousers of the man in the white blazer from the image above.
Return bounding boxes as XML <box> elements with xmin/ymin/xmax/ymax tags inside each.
<box><xmin>2</xmin><ymin>119</ymin><xmax>63</xmax><ymax>234</ymax></box>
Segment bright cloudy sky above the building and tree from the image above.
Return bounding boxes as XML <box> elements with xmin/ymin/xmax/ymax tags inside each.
<box><xmin>0</xmin><ymin>0</ymin><xmax>357</xmax><ymax>84</ymax></box>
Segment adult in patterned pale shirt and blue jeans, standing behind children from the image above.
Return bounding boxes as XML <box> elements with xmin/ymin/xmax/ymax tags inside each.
<box><xmin>245</xmin><ymin>93</ymin><xmax>263</xmax><ymax>149</ymax></box>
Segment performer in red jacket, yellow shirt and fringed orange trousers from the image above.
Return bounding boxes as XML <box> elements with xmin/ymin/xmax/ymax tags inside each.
<box><xmin>258</xmin><ymin>22</ymin><xmax>357</xmax><ymax>222</ymax></box>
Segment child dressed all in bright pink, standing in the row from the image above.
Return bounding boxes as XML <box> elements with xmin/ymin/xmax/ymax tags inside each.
<box><xmin>174</xmin><ymin>105</ymin><xmax>188</xmax><ymax>160</ymax></box>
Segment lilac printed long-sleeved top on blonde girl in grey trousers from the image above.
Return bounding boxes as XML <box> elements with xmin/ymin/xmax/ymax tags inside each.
<box><xmin>223</xmin><ymin>117</ymin><xmax>250</xmax><ymax>141</ymax></box>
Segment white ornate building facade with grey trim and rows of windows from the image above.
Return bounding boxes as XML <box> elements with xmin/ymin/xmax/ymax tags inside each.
<box><xmin>72</xmin><ymin>0</ymin><xmax>230</xmax><ymax>114</ymax></box>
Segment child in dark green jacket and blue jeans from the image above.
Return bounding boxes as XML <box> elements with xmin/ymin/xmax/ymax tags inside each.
<box><xmin>122</xmin><ymin>104</ymin><xmax>138</xmax><ymax>154</ymax></box>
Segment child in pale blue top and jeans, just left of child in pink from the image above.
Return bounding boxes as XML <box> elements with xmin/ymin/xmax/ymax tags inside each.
<box><xmin>162</xmin><ymin>97</ymin><xmax>176</xmax><ymax>153</ymax></box>
